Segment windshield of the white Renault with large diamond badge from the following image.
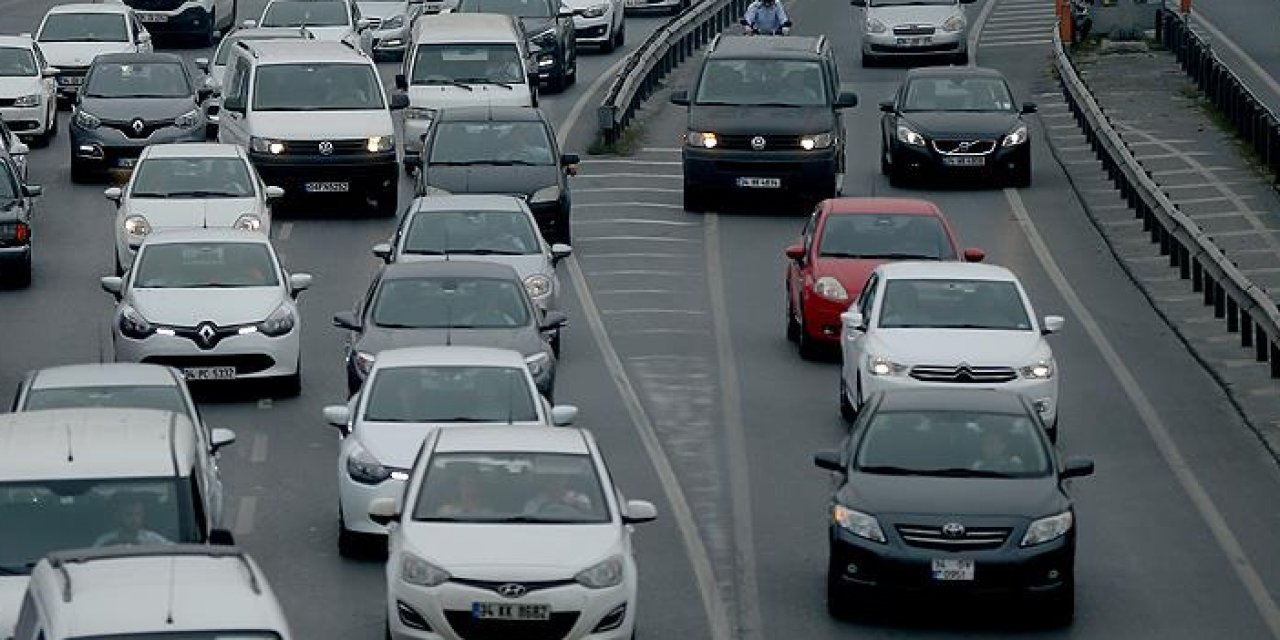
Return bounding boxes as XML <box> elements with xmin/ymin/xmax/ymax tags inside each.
<box><xmin>133</xmin><ymin>242</ymin><xmax>279</xmax><ymax>289</ymax></box>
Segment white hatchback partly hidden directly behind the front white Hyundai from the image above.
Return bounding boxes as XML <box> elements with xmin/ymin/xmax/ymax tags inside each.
<box><xmin>324</xmin><ymin>347</ymin><xmax>577</xmax><ymax>556</ymax></box>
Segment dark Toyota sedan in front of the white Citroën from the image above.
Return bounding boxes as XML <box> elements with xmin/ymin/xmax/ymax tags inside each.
<box><xmin>814</xmin><ymin>390</ymin><xmax>1093</xmax><ymax>625</ymax></box>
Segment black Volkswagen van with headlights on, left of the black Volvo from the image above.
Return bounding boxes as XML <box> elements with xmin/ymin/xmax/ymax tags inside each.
<box><xmin>671</xmin><ymin>36</ymin><xmax>858</xmax><ymax>211</ymax></box>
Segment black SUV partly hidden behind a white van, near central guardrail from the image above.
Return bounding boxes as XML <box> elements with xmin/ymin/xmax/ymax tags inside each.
<box><xmin>454</xmin><ymin>0</ymin><xmax>577</xmax><ymax>91</ymax></box>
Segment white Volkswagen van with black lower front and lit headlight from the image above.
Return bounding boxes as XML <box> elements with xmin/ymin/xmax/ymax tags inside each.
<box><xmin>218</xmin><ymin>39</ymin><xmax>408</xmax><ymax>215</ymax></box>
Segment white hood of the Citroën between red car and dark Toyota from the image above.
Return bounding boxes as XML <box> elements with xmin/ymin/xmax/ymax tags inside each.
<box><xmin>868</xmin><ymin>329</ymin><xmax>1048</xmax><ymax>367</ymax></box>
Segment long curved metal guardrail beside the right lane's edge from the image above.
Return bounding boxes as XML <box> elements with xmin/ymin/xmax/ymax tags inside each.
<box><xmin>1053</xmin><ymin>29</ymin><xmax>1280</xmax><ymax>378</ymax></box>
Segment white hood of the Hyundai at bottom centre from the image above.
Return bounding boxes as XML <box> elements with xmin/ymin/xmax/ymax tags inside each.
<box><xmin>406</xmin><ymin>522</ymin><xmax>620</xmax><ymax>580</ymax></box>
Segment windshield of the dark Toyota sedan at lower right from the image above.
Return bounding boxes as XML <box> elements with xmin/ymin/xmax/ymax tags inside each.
<box><xmin>854</xmin><ymin>410</ymin><xmax>1052</xmax><ymax>477</ymax></box>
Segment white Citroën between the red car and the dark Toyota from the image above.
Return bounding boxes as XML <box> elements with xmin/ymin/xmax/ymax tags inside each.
<box><xmin>840</xmin><ymin>262</ymin><xmax>1064</xmax><ymax>439</ymax></box>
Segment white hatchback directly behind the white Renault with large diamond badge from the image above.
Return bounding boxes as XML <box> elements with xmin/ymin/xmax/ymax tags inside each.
<box><xmin>104</xmin><ymin>142</ymin><xmax>284</xmax><ymax>275</ymax></box>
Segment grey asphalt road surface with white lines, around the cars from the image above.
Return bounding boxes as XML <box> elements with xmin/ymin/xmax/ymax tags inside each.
<box><xmin>0</xmin><ymin>0</ymin><xmax>1280</xmax><ymax>640</ymax></box>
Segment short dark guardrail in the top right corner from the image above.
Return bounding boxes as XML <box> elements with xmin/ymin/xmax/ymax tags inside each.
<box><xmin>1156</xmin><ymin>8</ymin><xmax>1280</xmax><ymax>183</ymax></box>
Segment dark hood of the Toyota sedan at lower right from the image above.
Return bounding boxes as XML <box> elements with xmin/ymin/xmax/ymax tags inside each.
<box><xmin>838</xmin><ymin>472</ymin><xmax>1068</xmax><ymax>517</ymax></box>
